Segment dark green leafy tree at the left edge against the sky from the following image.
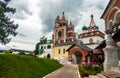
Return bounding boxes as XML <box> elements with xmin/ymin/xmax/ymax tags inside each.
<box><xmin>0</xmin><ymin>0</ymin><xmax>18</xmax><ymax>45</ymax></box>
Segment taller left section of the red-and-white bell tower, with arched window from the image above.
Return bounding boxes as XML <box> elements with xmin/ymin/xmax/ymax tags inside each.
<box><xmin>53</xmin><ymin>12</ymin><xmax>68</xmax><ymax>45</ymax></box>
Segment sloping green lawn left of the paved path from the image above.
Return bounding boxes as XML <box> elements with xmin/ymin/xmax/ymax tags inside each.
<box><xmin>0</xmin><ymin>54</ymin><xmax>62</xmax><ymax>78</ymax></box>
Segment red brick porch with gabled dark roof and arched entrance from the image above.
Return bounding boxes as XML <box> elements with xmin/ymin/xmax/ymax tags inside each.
<box><xmin>67</xmin><ymin>44</ymin><xmax>92</xmax><ymax>64</ymax></box>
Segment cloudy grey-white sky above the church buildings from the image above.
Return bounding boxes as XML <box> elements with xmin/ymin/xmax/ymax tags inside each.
<box><xmin>0</xmin><ymin>0</ymin><xmax>109</xmax><ymax>51</ymax></box>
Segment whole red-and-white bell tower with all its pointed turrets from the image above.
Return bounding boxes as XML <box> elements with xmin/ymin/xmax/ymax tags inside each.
<box><xmin>52</xmin><ymin>12</ymin><xmax>75</xmax><ymax>45</ymax></box>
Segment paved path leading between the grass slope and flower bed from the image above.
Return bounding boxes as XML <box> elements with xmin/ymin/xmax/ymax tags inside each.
<box><xmin>45</xmin><ymin>65</ymin><xmax>79</xmax><ymax>78</ymax></box>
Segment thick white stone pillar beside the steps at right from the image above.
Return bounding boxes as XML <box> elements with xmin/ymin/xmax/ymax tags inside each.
<box><xmin>103</xmin><ymin>31</ymin><xmax>118</xmax><ymax>71</ymax></box>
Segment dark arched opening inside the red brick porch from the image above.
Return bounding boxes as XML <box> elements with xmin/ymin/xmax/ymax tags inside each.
<box><xmin>72</xmin><ymin>52</ymin><xmax>82</xmax><ymax>64</ymax></box>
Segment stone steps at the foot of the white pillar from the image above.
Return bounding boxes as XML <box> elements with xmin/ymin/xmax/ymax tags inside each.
<box><xmin>85</xmin><ymin>67</ymin><xmax>120</xmax><ymax>78</ymax></box>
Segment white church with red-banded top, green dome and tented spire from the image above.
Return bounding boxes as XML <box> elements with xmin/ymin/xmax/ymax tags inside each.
<box><xmin>79</xmin><ymin>14</ymin><xmax>104</xmax><ymax>49</ymax></box>
